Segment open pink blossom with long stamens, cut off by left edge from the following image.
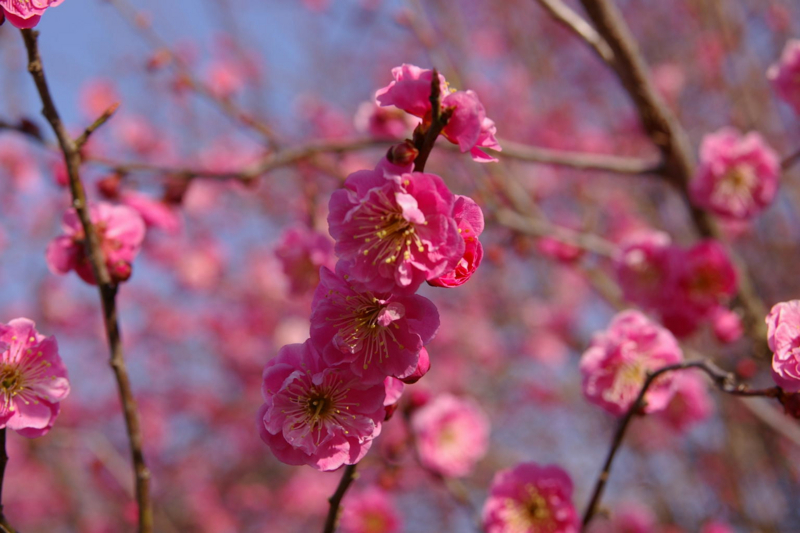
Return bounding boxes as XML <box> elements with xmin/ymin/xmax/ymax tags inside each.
<box><xmin>0</xmin><ymin>318</ymin><xmax>69</xmax><ymax>438</ymax></box>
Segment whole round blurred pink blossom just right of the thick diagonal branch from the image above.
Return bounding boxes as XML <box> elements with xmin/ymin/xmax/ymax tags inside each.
<box><xmin>690</xmin><ymin>128</ymin><xmax>780</xmax><ymax>219</ymax></box>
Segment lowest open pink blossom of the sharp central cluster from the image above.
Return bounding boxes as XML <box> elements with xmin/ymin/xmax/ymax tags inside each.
<box><xmin>258</xmin><ymin>341</ymin><xmax>385</xmax><ymax>471</ymax></box>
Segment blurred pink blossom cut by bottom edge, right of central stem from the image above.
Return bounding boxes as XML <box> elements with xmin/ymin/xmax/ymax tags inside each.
<box><xmin>342</xmin><ymin>485</ymin><xmax>402</xmax><ymax>533</ymax></box>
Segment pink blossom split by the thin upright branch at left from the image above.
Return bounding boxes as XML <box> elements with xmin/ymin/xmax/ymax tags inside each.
<box><xmin>46</xmin><ymin>202</ymin><xmax>145</xmax><ymax>284</ymax></box>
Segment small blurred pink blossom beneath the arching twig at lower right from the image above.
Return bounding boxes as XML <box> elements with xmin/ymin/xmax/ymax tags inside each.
<box><xmin>657</xmin><ymin>370</ymin><xmax>714</xmax><ymax>432</ymax></box>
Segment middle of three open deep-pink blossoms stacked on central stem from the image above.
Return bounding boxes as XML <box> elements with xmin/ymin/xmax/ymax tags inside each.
<box><xmin>311</xmin><ymin>262</ymin><xmax>439</xmax><ymax>383</ymax></box>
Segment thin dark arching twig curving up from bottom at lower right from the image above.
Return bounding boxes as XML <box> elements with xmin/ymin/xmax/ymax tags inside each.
<box><xmin>583</xmin><ymin>360</ymin><xmax>785</xmax><ymax>528</ymax></box>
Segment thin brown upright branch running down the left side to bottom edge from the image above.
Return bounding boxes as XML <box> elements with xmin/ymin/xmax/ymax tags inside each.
<box><xmin>22</xmin><ymin>30</ymin><xmax>153</xmax><ymax>533</ymax></box>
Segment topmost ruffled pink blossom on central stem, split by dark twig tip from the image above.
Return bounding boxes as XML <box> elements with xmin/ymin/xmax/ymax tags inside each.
<box><xmin>375</xmin><ymin>63</ymin><xmax>502</xmax><ymax>163</ymax></box>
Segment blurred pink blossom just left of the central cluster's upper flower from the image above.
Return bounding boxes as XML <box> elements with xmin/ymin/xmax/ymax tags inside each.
<box><xmin>275</xmin><ymin>226</ymin><xmax>335</xmax><ymax>295</ymax></box>
